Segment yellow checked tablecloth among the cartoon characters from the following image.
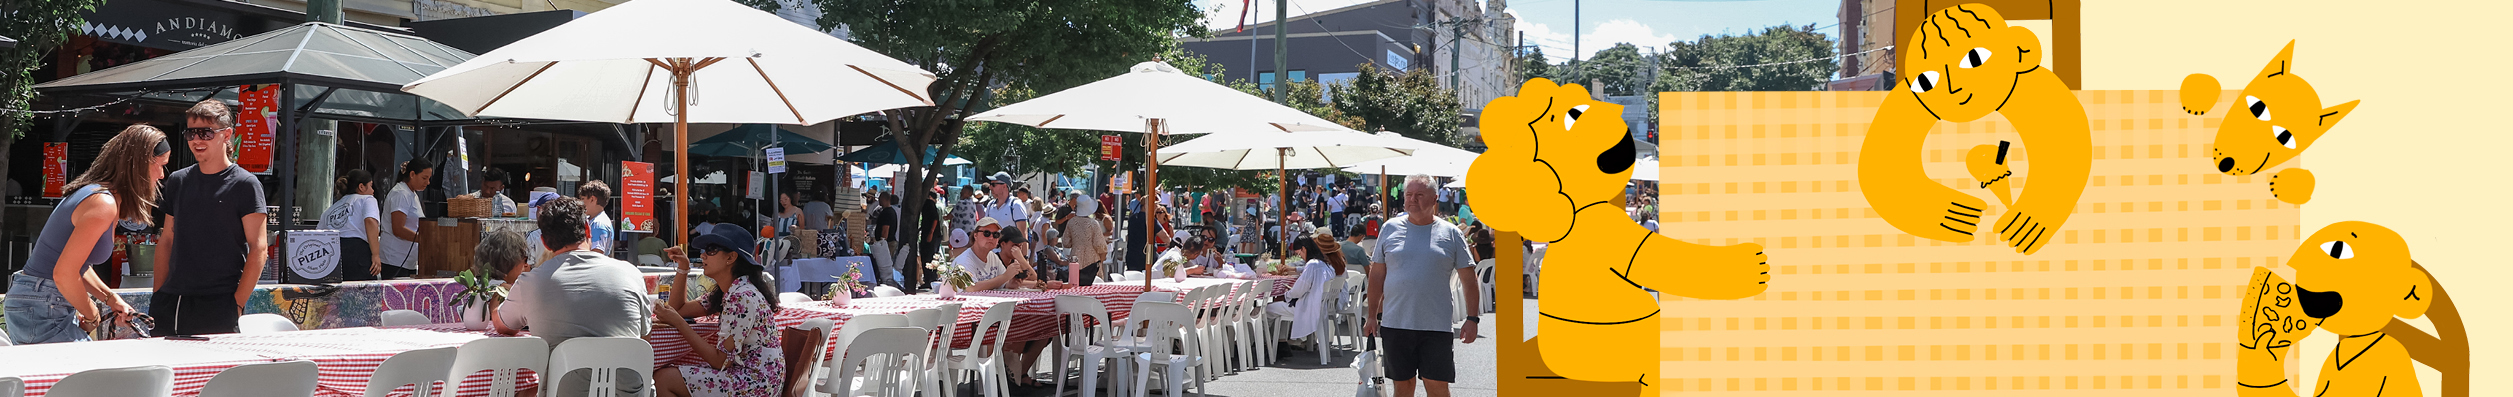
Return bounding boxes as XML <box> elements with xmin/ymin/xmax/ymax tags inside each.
<box><xmin>1659</xmin><ymin>90</ymin><xmax>2291</xmax><ymax>397</ymax></box>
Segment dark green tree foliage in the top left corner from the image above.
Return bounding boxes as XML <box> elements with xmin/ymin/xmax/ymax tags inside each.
<box><xmin>0</xmin><ymin>0</ymin><xmax>103</xmax><ymax>217</ymax></box>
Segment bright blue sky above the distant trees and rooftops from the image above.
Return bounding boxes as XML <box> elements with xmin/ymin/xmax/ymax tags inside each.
<box><xmin>1196</xmin><ymin>0</ymin><xmax>1842</xmax><ymax>63</ymax></box>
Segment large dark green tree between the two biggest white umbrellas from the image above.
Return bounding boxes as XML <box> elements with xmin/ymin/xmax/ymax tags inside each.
<box><xmin>814</xmin><ymin>0</ymin><xmax>1206</xmax><ymax>253</ymax></box>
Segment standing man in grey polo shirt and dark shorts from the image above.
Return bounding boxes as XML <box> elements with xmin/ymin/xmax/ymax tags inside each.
<box><xmin>1367</xmin><ymin>173</ymin><xmax>1483</xmax><ymax>397</ymax></box>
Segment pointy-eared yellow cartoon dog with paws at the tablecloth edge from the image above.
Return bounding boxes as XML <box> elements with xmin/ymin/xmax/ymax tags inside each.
<box><xmin>2181</xmin><ymin>40</ymin><xmax>2357</xmax><ymax>204</ymax></box>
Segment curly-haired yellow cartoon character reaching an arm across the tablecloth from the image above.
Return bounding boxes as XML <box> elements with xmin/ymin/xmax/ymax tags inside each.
<box><xmin>1465</xmin><ymin>78</ymin><xmax>1772</xmax><ymax>394</ymax></box>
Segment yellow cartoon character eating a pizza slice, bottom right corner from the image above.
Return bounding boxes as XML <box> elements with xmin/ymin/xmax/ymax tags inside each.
<box><xmin>2234</xmin><ymin>221</ymin><xmax>2468</xmax><ymax>397</ymax></box>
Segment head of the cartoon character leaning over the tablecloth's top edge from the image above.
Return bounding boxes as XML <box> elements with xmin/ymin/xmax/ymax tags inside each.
<box><xmin>1895</xmin><ymin>3</ymin><xmax>2041</xmax><ymax>123</ymax></box>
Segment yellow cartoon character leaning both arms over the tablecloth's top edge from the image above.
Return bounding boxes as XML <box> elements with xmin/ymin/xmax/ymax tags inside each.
<box><xmin>1860</xmin><ymin>5</ymin><xmax>2093</xmax><ymax>254</ymax></box>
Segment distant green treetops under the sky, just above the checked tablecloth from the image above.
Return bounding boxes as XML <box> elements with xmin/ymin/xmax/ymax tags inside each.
<box><xmin>1651</xmin><ymin>25</ymin><xmax>1840</xmax><ymax>90</ymax></box>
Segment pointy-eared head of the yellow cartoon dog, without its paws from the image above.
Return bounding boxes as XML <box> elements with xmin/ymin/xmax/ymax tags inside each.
<box><xmin>2209</xmin><ymin>40</ymin><xmax>2357</xmax><ymax>176</ymax></box>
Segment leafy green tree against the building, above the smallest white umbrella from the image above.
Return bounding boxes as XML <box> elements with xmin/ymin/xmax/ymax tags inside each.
<box><xmin>1327</xmin><ymin>65</ymin><xmax>1463</xmax><ymax>146</ymax></box>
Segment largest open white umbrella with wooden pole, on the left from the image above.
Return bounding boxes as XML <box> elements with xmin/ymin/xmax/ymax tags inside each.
<box><xmin>402</xmin><ymin>0</ymin><xmax>935</xmax><ymax>244</ymax></box>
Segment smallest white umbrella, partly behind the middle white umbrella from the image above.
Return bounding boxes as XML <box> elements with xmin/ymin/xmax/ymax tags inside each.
<box><xmin>1158</xmin><ymin>131</ymin><xmax>1415</xmax><ymax>256</ymax></box>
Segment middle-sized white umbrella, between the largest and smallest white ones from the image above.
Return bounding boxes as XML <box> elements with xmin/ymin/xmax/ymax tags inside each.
<box><xmin>968</xmin><ymin>60</ymin><xmax>1352</xmax><ymax>289</ymax></box>
